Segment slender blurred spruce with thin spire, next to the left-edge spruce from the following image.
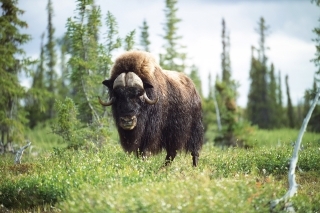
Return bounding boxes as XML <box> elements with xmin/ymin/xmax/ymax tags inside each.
<box><xmin>25</xmin><ymin>0</ymin><xmax>66</xmax><ymax>128</ymax></box>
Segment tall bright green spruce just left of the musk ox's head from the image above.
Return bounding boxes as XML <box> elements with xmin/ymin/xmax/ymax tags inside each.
<box><xmin>67</xmin><ymin>0</ymin><xmax>101</xmax><ymax>123</ymax></box>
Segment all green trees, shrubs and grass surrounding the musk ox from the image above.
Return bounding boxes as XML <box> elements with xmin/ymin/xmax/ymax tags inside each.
<box><xmin>0</xmin><ymin>0</ymin><xmax>320</xmax><ymax>212</ymax></box>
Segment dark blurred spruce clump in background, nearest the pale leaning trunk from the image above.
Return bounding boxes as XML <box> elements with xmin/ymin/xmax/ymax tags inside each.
<box><xmin>246</xmin><ymin>18</ymin><xmax>297</xmax><ymax>129</ymax></box>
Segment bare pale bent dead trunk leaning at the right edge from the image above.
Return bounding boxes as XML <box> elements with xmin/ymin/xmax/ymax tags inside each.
<box><xmin>271</xmin><ymin>87</ymin><xmax>320</xmax><ymax>212</ymax></box>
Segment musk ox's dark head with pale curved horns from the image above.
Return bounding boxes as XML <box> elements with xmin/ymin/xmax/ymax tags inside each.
<box><xmin>99</xmin><ymin>72</ymin><xmax>158</xmax><ymax>130</ymax></box>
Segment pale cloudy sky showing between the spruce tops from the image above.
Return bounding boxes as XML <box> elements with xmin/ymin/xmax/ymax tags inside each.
<box><xmin>18</xmin><ymin>0</ymin><xmax>320</xmax><ymax>107</ymax></box>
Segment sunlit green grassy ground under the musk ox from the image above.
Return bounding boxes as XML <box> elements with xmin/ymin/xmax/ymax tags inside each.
<box><xmin>0</xmin><ymin>129</ymin><xmax>320</xmax><ymax>212</ymax></box>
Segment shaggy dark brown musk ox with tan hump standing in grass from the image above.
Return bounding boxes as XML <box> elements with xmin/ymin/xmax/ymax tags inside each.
<box><xmin>99</xmin><ymin>51</ymin><xmax>203</xmax><ymax>166</ymax></box>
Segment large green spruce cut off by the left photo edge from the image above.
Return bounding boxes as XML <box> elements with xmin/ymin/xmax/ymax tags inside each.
<box><xmin>0</xmin><ymin>0</ymin><xmax>31</xmax><ymax>153</ymax></box>
